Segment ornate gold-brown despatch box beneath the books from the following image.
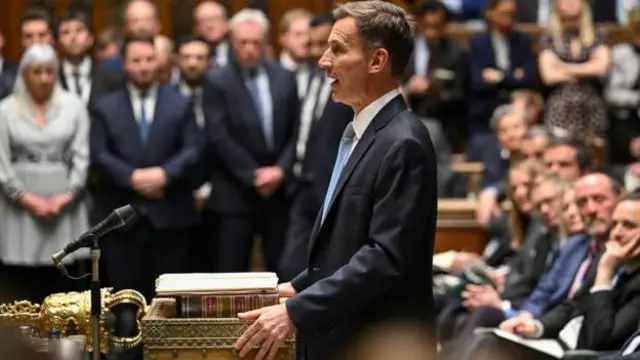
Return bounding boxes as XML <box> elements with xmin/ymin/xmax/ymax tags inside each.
<box><xmin>142</xmin><ymin>298</ymin><xmax>296</xmax><ymax>360</ymax></box>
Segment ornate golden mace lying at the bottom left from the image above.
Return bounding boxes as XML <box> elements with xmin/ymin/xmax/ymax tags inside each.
<box><xmin>0</xmin><ymin>288</ymin><xmax>147</xmax><ymax>353</ymax></box>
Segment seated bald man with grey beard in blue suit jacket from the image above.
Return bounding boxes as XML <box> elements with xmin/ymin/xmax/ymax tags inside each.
<box><xmin>450</xmin><ymin>174</ymin><xmax>622</xmax><ymax>333</ymax></box>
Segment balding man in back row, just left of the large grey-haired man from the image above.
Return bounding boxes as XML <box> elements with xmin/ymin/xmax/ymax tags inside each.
<box><xmin>193</xmin><ymin>1</ymin><xmax>231</xmax><ymax>69</ymax></box>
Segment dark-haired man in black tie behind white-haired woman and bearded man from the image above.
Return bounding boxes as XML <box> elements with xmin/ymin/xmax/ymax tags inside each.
<box><xmin>55</xmin><ymin>10</ymin><xmax>123</xmax><ymax>105</ymax></box>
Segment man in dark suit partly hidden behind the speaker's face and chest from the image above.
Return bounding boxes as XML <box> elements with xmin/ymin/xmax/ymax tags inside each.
<box><xmin>280</xmin><ymin>14</ymin><xmax>353</xmax><ymax>281</ymax></box>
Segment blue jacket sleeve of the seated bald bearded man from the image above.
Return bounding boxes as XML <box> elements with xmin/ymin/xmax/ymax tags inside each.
<box><xmin>520</xmin><ymin>234</ymin><xmax>591</xmax><ymax>317</ymax></box>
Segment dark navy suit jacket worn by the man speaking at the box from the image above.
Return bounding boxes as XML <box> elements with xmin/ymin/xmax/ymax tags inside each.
<box><xmin>286</xmin><ymin>96</ymin><xmax>438</xmax><ymax>360</ymax></box>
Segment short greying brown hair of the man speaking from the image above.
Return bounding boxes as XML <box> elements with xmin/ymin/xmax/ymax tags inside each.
<box><xmin>333</xmin><ymin>0</ymin><xmax>415</xmax><ymax>76</ymax></box>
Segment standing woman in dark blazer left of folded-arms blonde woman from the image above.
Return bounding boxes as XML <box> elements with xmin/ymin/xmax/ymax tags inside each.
<box><xmin>469</xmin><ymin>0</ymin><xmax>537</xmax><ymax>141</ymax></box>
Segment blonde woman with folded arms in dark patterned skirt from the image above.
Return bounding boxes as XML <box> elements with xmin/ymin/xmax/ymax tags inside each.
<box><xmin>539</xmin><ymin>0</ymin><xmax>610</xmax><ymax>140</ymax></box>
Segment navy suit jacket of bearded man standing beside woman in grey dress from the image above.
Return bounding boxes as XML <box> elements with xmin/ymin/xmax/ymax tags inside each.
<box><xmin>91</xmin><ymin>86</ymin><xmax>204</xmax><ymax>229</ymax></box>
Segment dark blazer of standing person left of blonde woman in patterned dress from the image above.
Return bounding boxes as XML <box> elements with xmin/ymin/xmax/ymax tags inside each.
<box><xmin>469</xmin><ymin>31</ymin><xmax>537</xmax><ymax>132</ymax></box>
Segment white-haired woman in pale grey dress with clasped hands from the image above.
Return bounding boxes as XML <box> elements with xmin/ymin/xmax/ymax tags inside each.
<box><xmin>0</xmin><ymin>44</ymin><xmax>90</xmax><ymax>301</ymax></box>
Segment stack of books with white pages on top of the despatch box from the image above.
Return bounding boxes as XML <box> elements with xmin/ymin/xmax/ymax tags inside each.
<box><xmin>156</xmin><ymin>272</ymin><xmax>279</xmax><ymax>318</ymax></box>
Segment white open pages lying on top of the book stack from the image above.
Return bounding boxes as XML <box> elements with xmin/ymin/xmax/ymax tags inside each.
<box><xmin>156</xmin><ymin>272</ymin><xmax>278</xmax><ymax>296</ymax></box>
